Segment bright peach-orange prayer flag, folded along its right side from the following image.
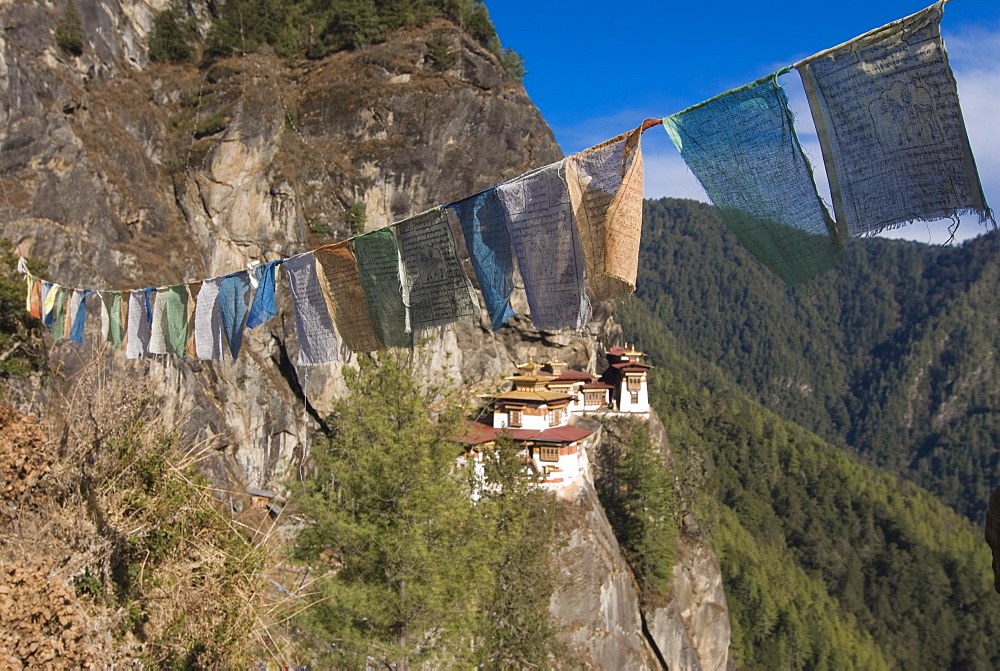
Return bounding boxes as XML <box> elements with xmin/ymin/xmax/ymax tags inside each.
<box><xmin>566</xmin><ymin>119</ymin><xmax>660</xmax><ymax>300</ymax></box>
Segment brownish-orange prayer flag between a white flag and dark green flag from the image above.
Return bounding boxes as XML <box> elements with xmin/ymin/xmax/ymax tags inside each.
<box><xmin>313</xmin><ymin>241</ymin><xmax>382</xmax><ymax>352</ymax></box>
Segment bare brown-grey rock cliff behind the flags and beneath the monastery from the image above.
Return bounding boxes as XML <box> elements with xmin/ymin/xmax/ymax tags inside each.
<box><xmin>0</xmin><ymin>0</ymin><xmax>728</xmax><ymax>669</ymax></box>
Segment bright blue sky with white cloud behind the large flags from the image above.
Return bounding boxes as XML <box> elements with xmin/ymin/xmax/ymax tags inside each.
<box><xmin>486</xmin><ymin>0</ymin><xmax>1000</xmax><ymax>243</ymax></box>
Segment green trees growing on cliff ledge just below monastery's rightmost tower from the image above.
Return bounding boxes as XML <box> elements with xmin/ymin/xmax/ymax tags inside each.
<box><xmin>597</xmin><ymin>419</ymin><xmax>678</xmax><ymax>607</ymax></box>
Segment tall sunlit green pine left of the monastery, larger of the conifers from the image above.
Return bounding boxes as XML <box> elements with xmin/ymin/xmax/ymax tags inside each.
<box><xmin>292</xmin><ymin>355</ymin><xmax>492</xmax><ymax>669</ymax></box>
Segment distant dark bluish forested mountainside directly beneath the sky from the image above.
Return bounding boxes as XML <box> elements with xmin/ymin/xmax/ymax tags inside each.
<box><xmin>637</xmin><ymin>198</ymin><xmax>1000</xmax><ymax>521</ymax></box>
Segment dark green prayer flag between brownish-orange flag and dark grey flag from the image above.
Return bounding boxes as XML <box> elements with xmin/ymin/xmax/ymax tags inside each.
<box><xmin>351</xmin><ymin>228</ymin><xmax>413</xmax><ymax>347</ymax></box>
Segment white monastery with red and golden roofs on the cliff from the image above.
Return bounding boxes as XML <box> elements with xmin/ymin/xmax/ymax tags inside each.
<box><xmin>462</xmin><ymin>346</ymin><xmax>652</xmax><ymax>489</ymax></box>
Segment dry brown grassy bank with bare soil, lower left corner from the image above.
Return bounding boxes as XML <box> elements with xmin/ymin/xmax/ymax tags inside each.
<box><xmin>0</xmin><ymin>366</ymin><xmax>304</xmax><ymax>668</ymax></box>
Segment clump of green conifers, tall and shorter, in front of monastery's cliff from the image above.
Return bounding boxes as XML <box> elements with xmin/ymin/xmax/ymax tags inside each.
<box><xmin>298</xmin><ymin>355</ymin><xmax>554</xmax><ymax>668</ymax></box>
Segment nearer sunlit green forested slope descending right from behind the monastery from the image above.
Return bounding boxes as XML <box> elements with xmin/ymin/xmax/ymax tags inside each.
<box><xmin>616</xmin><ymin>300</ymin><xmax>1000</xmax><ymax>669</ymax></box>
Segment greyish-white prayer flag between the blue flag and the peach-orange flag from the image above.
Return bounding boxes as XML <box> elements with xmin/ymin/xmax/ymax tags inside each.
<box><xmin>497</xmin><ymin>160</ymin><xmax>590</xmax><ymax>331</ymax></box>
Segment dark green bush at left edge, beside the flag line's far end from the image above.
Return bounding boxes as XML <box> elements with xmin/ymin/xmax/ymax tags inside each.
<box><xmin>0</xmin><ymin>240</ymin><xmax>47</xmax><ymax>377</ymax></box>
